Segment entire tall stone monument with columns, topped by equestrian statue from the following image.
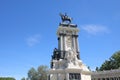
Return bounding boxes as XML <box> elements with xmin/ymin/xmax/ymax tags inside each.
<box><xmin>48</xmin><ymin>14</ymin><xmax>91</xmax><ymax>80</ymax></box>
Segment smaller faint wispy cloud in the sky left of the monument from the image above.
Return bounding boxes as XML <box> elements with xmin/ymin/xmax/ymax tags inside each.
<box><xmin>26</xmin><ymin>34</ymin><xmax>40</xmax><ymax>47</ymax></box>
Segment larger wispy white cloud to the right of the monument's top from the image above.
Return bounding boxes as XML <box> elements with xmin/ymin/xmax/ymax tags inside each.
<box><xmin>82</xmin><ymin>25</ymin><xmax>110</xmax><ymax>35</ymax></box>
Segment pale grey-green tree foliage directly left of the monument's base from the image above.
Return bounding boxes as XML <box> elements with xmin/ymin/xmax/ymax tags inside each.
<box><xmin>28</xmin><ymin>65</ymin><xmax>48</xmax><ymax>80</ymax></box>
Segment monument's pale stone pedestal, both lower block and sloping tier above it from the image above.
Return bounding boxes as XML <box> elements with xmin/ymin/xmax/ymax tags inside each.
<box><xmin>49</xmin><ymin>60</ymin><xmax>91</xmax><ymax>80</ymax></box>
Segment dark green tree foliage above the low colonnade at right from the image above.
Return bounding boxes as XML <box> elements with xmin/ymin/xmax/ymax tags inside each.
<box><xmin>96</xmin><ymin>51</ymin><xmax>120</xmax><ymax>71</ymax></box>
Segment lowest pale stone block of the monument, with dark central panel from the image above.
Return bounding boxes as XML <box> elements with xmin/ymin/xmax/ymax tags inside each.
<box><xmin>48</xmin><ymin>69</ymin><xmax>91</xmax><ymax>80</ymax></box>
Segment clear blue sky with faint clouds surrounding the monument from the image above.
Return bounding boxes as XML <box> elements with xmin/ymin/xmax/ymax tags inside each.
<box><xmin>0</xmin><ymin>0</ymin><xmax>120</xmax><ymax>80</ymax></box>
